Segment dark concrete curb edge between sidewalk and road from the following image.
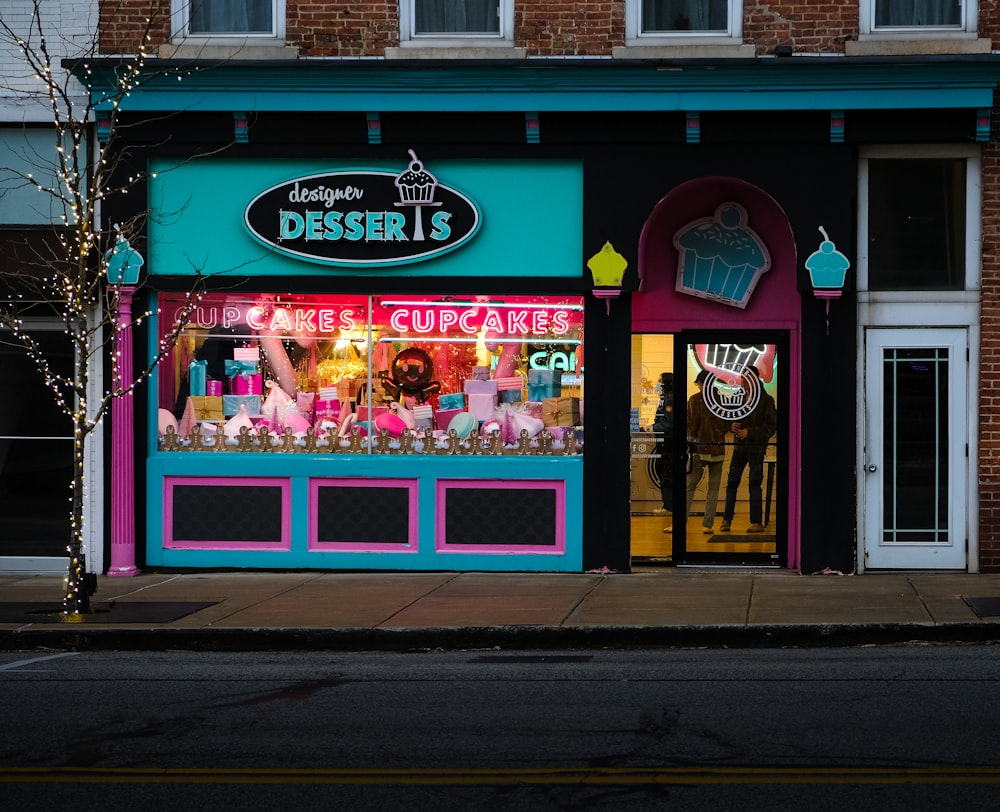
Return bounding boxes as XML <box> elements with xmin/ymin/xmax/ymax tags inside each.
<box><xmin>0</xmin><ymin>623</ymin><xmax>1000</xmax><ymax>652</ymax></box>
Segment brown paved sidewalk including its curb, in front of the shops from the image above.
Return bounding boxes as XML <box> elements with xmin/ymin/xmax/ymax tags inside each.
<box><xmin>0</xmin><ymin>568</ymin><xmax>1000</xmax><ymax>651</ymax></box>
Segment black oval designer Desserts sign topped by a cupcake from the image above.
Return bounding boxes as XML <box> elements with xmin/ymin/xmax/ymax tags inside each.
<box><xmin>243</xmin><ymin>150</ymin><xmax>482</xmax><ymax>267</ymax></box>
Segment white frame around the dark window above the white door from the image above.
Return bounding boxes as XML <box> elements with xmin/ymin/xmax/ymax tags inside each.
<box><xmin>858</xmin><ymin>144</ymin><xmax>983</xmax><ymax>296</ymax></box>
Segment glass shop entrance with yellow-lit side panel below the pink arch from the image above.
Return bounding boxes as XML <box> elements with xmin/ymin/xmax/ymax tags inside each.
<box><xmin>631</xmin><ymin>331</ymin><xmax>788</xmax><ymax>566</ymax></box>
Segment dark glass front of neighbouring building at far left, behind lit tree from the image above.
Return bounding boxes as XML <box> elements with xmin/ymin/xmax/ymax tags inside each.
<box><xmin>0</xmin><ymin>331</ymin><xmax>73</xmax><ymax>557</ymax></box>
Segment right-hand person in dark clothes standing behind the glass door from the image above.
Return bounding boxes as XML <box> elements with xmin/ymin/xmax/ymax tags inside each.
<box><xmin>719</xmin><ymin>366</ymin><xmax>778</xmax><ymax>533</ymax></box>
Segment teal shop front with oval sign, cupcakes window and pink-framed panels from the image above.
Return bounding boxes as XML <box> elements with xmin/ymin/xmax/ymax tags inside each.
<box><xmin>139</xmin><ymin>150</ymin><xmax>585</xmax><ymax>571</ymax></box>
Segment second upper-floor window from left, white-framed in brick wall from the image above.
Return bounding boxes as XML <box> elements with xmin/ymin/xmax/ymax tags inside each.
<box><xmin>399</xmin><ymin>0</ymin><xmax>514</xmax><ymax>47</ymax></box>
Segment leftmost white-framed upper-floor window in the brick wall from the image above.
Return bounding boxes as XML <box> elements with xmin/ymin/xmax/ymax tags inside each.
<box><xmin>173</xmin><ymin>0</ymin><xmax>285</xmax><ymax>42</ymax></box>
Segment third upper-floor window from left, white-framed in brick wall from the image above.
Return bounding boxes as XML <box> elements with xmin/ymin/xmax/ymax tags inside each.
<box><xmin>625</xmin><ymin>0</ymin><xmax>743</xmax><ymax>45</ymax></box>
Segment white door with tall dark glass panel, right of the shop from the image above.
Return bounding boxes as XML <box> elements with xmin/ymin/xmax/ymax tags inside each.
<box><xmin>861</xmin><ymin>328</ymin><xmax>969</xmax><ymax>570</ymax></box>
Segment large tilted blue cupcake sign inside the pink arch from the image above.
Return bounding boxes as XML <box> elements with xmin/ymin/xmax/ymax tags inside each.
<box><xmin>673</xmin><ymin>201</ymin><xmax>771</xmax><ymax>309</ymax></box>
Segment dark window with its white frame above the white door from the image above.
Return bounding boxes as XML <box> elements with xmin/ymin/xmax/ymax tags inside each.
<box><xmin>859</xmin><ymin>147</ymin><xmax>980</xmax><ymax>291</ymax></box>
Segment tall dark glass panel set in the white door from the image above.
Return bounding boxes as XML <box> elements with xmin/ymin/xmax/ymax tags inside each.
<box><xmin>882</xmin><ymin>347</ymin><xmax>949</xmax><ymax>543</ymax></box>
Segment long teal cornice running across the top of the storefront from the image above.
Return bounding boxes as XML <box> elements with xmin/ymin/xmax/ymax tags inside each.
<box><xmin>78</xmin><ymin>54</ymin><xmax>1000</xmax><ymax>113</ymax></box>
